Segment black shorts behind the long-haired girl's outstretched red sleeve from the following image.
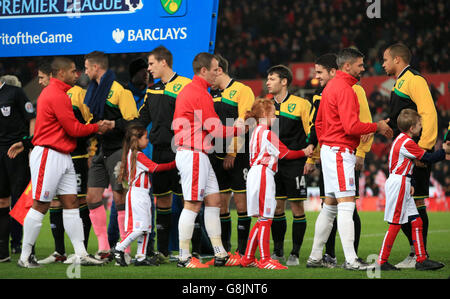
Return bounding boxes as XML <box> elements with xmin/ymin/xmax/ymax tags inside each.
<box><xmin>152</xmin><ymin>146</ymin><xmax>183</xmax><ymax>196</ymax></box>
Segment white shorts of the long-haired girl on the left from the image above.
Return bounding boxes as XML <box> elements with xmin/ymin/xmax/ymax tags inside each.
<box><xmin>125</xmin><ymin>186</ymin><xmax>152</xmax><ymax>232</ymax></box>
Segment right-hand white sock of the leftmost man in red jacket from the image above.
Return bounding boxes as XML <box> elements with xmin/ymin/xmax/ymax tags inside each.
<box><xmin>63</xmin><ymin>208</ymin><xmax>88</xmax><ymax>256</ymax></box>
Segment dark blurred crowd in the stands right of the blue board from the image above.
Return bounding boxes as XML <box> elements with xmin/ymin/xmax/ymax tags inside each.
<box><xmin>216</xmin><ymin>0</ymin><xmax>450</xmax><ymax>79</ymax></box>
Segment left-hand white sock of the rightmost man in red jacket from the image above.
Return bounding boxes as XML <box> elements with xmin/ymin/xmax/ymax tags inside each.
<box><xmin>310</xmin><ymin>203</ymin><xmax>337</xmax><ymax>260</ymax></box>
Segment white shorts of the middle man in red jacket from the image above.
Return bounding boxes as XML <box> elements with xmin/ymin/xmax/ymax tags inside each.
<box><xmin>175</xmin><ymin>149</ymin><xmax>219</xmax><ymax>201</ymax></box>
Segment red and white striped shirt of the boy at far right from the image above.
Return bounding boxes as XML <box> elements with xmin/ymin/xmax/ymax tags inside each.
<box><xmin>389</xmin><ymin>133</ymin><xmax>425</xmax><ymax>175</ymax></box>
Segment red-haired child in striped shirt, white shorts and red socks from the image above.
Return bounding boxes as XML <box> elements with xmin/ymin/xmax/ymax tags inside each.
<box><xmin>241</xmin><ymin>98</ymin><xmax>312</xmax><ymax>270</ymax></box>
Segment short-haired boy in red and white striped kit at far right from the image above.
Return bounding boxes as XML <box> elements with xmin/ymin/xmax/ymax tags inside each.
<box><xmin>378</xmin><ymin>109</ymin><xmax>450</xmax><ymax>270</ymax></box>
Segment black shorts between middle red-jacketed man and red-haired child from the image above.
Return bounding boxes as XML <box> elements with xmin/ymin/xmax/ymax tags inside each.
<box><xmin>209</xmin><ymin>153</ymin><xmax>250</xmax><ymax>193</ymax></box>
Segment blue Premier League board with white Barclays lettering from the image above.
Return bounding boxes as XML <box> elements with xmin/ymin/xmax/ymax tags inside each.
<box><xmin>0</xmin><ymin>0</ymin><xmax>219</xmax><ymax>76</ymax></box>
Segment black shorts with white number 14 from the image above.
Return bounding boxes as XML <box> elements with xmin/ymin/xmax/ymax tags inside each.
<box><xmin>275</xmin><ymin>159</ymin><xmax>308</xmax><ymax>201</ymax></box>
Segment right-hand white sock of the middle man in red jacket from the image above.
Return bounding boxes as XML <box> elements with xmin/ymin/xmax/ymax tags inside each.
<box><xmin>205</xmin><ymin>207</ymin><xmax>228</xmax><ymax>257</ymax></box>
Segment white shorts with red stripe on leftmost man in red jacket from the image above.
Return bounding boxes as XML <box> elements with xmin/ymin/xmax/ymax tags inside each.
<box><xmin>30</xmin><ymin>146</ymin><xmax>77</xmax><ymax>202</ymax></box>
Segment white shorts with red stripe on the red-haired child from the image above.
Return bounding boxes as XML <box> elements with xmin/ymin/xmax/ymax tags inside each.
<box><xmin>247</xmin><ymin>165</ymin><xmax>277</xmax><ymax>218</ymax></box>
